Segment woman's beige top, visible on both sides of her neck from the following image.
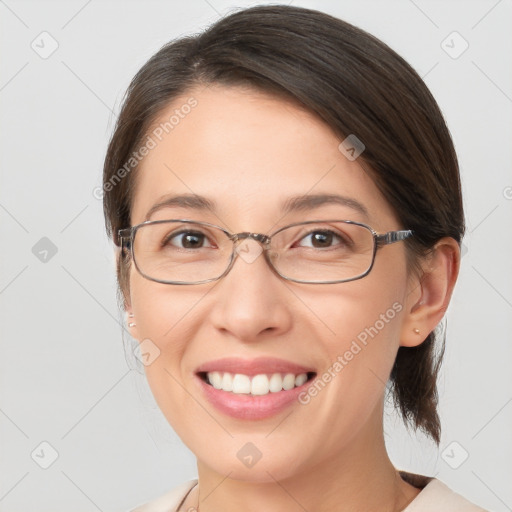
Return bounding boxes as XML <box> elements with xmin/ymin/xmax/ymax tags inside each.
<box><xmin>131</xmin><ymin>471</ymin><xmax>487</xmax><ymax>512</ymax></box>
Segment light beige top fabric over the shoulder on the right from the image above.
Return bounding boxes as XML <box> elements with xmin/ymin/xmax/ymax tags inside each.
<box><xmin>403</xmin><ymin>478</ymin><xmax>487</xmax><ymax>512</ymax></box>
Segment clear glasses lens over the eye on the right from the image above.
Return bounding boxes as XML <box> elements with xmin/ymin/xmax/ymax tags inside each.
<box><xmin>270</xmin><ymin>221</ymin><xmax>374</xmax><ymax>283</ymax></box>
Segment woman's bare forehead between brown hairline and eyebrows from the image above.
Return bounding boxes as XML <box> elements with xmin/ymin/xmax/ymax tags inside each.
<box><xmin>132</xmin><ymin>85</ymin><xmax>393</xmax><ymax>229</ymax></box>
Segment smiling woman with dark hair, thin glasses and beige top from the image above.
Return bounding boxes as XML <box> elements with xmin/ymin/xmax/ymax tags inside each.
<box><xmin>103</xmin><ymin>6</ymin><xmax>488</xmax><ymax>512</ymax></box>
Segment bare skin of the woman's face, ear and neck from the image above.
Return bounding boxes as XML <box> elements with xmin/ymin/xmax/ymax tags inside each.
<box><xmin>121</xmin><ymin>85</ymin><xmax>459</xmax><ymax>512</ymax></box>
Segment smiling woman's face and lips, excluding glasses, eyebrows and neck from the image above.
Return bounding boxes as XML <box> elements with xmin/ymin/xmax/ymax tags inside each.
<box><xmin>127</xmin><ymin>86</ymin><xmax>411</xmax><ymax>482</ymax></box>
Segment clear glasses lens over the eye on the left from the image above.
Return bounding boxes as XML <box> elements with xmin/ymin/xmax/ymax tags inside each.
<box><xmin>134</xmin><ymin>221</ymin><xmax>233</xmax><ymax>283</ymax></box>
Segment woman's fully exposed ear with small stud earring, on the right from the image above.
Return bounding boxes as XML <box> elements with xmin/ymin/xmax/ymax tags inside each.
<box><xmin>400</xmin><ymin>237</ymin><xmax>460</xmax><ymax>347</ymax></box>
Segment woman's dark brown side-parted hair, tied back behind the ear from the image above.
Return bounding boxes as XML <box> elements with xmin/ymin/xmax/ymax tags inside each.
<box><xmin>103</xmin><ymin>5</ymin><xmax>465</xmax><ymax>444</ymax></box>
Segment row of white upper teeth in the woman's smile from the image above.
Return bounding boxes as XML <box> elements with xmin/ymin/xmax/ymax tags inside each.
<box><xmin>206</xmin><ymin>372</ymin><xmax>308</xmax><ymax>395</ymax></box>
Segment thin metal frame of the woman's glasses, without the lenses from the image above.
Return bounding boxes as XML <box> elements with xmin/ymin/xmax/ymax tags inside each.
<box><xmin>118</xmin><ymin>219</ymin><xmax>414</xmax><ymax>285</ymax></box>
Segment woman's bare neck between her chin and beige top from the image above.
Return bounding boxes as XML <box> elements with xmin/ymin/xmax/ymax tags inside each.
<box><xmin>188</xmin><ymin>405</ymin><xmax>419</xmax><ymax>512</ymax></box>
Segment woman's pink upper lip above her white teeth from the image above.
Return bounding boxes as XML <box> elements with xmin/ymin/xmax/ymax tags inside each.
<box><xmin>196</xmin><ymin>357</ymin><xmax>314</xmax><ymax>376</ymax></box>
